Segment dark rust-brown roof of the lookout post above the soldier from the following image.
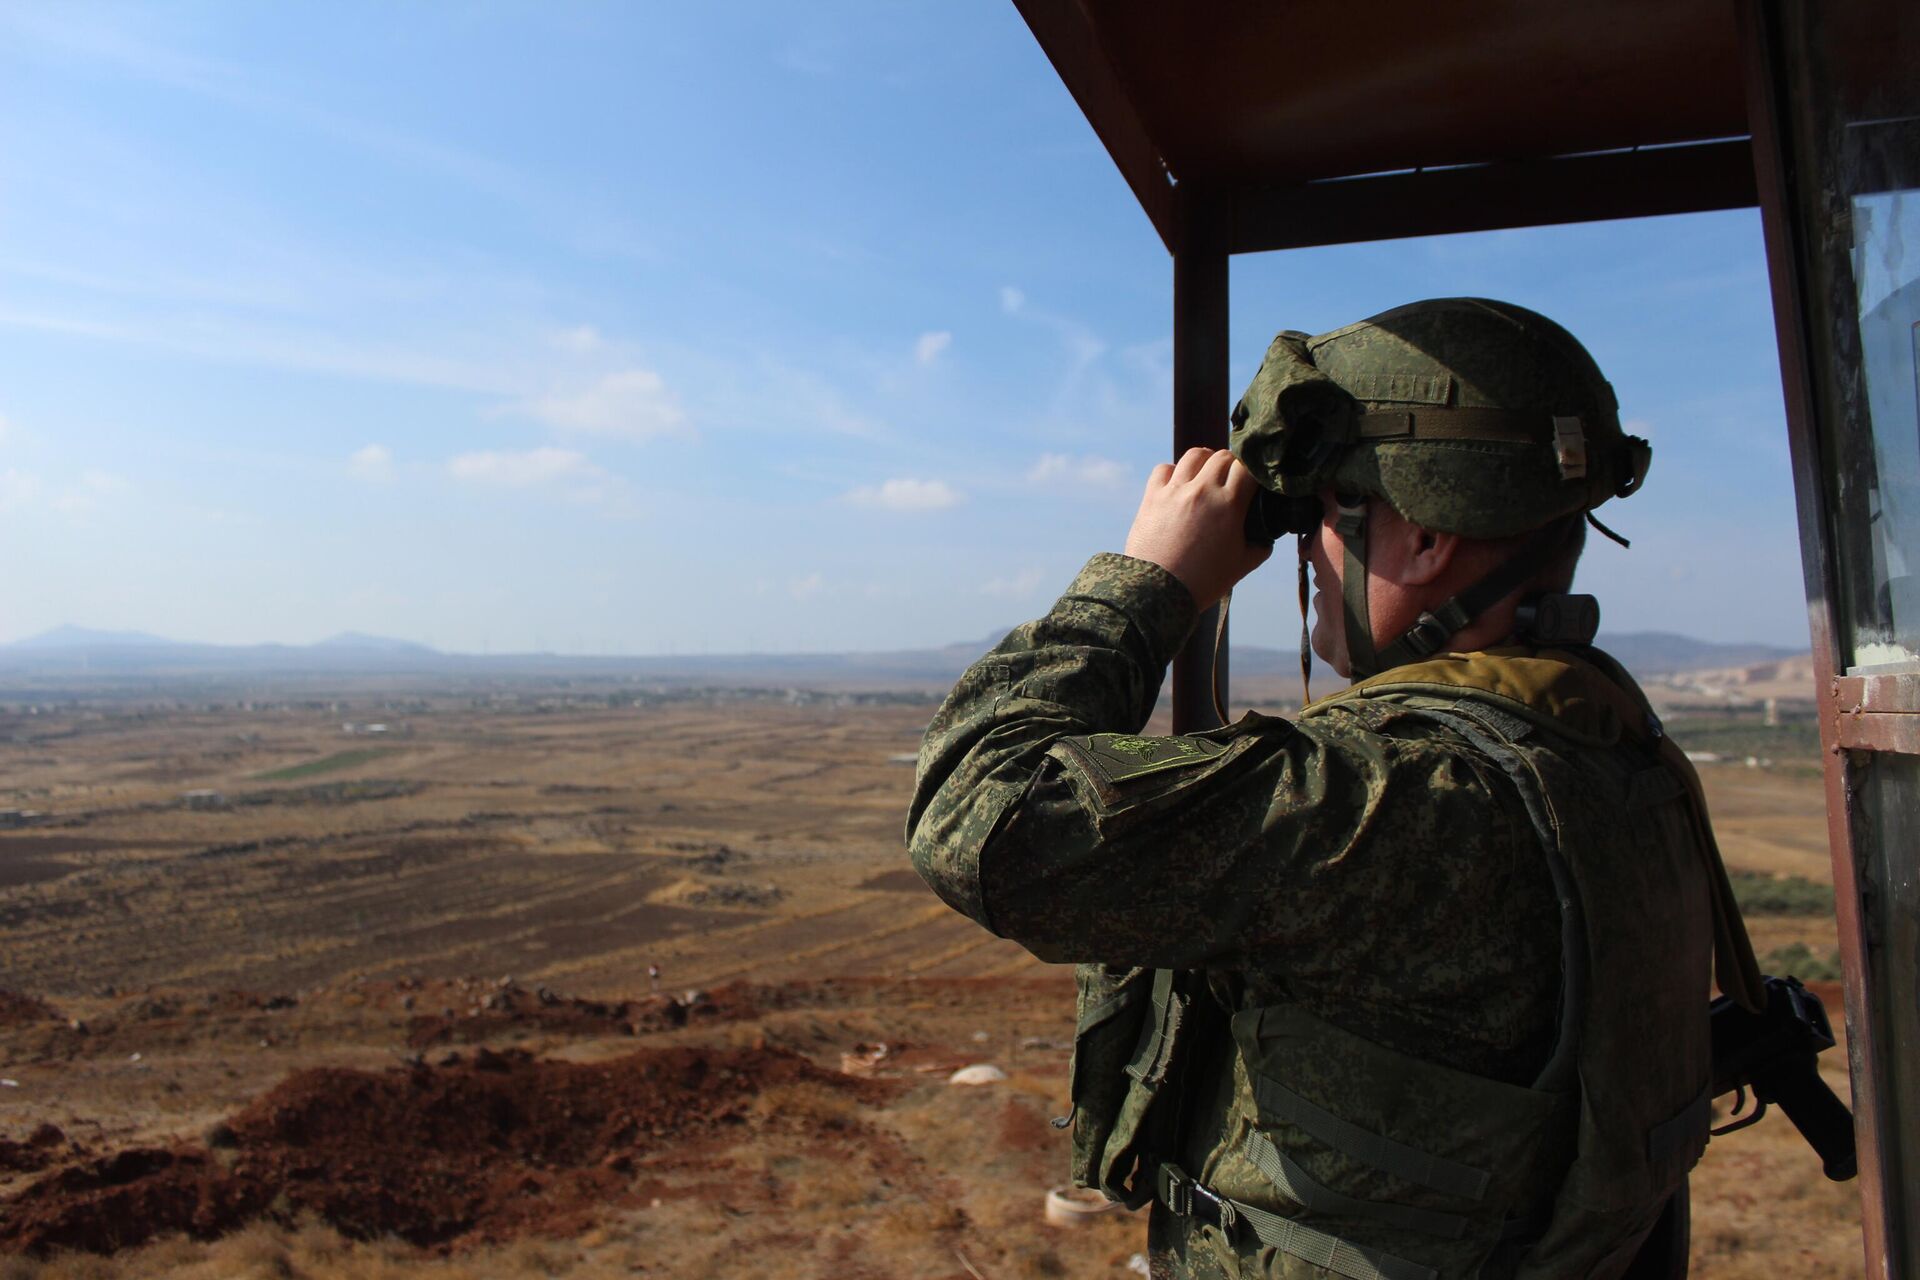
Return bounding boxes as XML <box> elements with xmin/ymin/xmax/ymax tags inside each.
<box><xmin>1016</xmin><ymin>0</ymin><xmax>1755</xmax><ymax>251</ymax></box>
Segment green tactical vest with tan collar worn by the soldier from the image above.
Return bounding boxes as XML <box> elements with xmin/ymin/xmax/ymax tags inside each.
<box><xmin>1071</xmin><ymin>651</ymin><xmax>1759</xmax><ymax>1280</ymax></box>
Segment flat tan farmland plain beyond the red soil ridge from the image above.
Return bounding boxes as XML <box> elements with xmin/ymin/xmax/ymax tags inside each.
<box><xmin>0</xmin><ymin>702</ymin><xmax>1023</xmax><ymax>1000</ymax></box>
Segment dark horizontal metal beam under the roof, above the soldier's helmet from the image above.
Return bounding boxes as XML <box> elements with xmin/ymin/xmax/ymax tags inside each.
<box><xmin>1231</xmin><ymin>138</ymin><xmax>1757</xmax><ymax>253</ymax></box>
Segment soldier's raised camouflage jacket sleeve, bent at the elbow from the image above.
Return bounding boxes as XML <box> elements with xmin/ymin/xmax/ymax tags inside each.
<box><xmin>908</xmin><ymin>557</ymin><xmax>1553</xmax><ymax>1002</ymax></box>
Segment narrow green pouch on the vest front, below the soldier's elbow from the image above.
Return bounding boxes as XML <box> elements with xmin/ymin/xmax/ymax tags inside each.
<box><xmin>1069</xmin><ymin>965</ymin><xmax>1187</xmax><ymax>1209</ymax></box>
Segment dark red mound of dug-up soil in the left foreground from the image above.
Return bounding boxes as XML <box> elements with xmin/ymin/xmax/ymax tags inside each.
<box><xmin>0</xmin><ymin>1048</ymin><xmax>891</xmax><ymax>1251</ymax></box>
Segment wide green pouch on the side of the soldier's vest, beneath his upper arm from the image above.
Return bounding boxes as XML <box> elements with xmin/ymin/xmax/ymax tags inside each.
<box><xmin>1210</xmin><ymin>1004</ymin><xmax>1572</xmax><ymax>1274</ymax></box>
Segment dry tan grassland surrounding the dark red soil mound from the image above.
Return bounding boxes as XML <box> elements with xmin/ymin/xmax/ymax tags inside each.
<box><xmin>0</xmin><ymin>704</ymin><xmax>1860</xmax><ymax>1280</ymax></box>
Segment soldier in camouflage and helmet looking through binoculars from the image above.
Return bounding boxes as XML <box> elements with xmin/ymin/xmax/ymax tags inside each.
<box><xmin>908</xmin><ymin>299</ymin><xmax>1759</xmax><ymax>1280</ymax></box>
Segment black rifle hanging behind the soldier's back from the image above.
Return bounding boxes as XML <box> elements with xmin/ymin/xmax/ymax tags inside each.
<box><xmin>1709</xmin><ymin>977</ymin><xmax>1857</xmax><ymax>1182</ymax></box>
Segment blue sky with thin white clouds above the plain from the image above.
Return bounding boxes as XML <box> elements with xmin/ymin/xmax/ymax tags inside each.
<box><xmin>0</xmin><ymin>0</ymin><xmax>1807</xmax><ymax>652</ymax></box>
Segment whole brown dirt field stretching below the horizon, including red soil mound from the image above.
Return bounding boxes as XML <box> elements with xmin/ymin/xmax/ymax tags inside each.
<box><xmin>0</xmin><ymin>693</ymin><xmax>1860</xmax><ymax>1280</ymax></box>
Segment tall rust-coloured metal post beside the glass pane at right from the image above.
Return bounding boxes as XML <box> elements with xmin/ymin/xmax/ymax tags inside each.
<box><xmin>1738</xmin><ymin>0</ymin><xmax>1893</xmax><ymax>1280</ymax></box>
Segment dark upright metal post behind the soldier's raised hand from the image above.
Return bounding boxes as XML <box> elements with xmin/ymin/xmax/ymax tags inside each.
<box><xmin>1173</xmin><ymin>182</ymin><xmax>1229</xmax><ymax>733</ymax></box>
